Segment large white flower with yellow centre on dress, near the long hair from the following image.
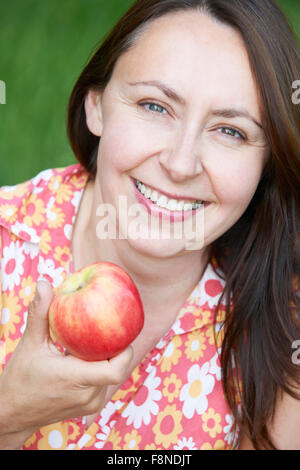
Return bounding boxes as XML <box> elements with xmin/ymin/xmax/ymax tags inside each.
<box><xmin>179</xmin><ymin>362</ymin><xmax>215</xmax><ymax>419</ymax></box>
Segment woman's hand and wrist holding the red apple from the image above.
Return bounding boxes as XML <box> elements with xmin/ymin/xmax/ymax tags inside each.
<box><xmin>0</xmin><ymin>281</ymin><xmax>133</xmax><ymax>449</ymax></box>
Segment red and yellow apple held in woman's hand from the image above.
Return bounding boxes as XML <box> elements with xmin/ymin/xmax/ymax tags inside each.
<box><xmin>49</xmin><ymin>262</ymin><xmax>144</xmax><ymax>361</ymax></box>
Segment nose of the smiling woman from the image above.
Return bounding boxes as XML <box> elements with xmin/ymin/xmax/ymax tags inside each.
<box><xmin>159</xmin><ymin>135</ymin><xmax>203</xmax><ymax>183</ymax></box>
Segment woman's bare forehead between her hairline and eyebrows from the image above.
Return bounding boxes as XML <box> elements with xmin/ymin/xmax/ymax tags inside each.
<box><xmin>112</xmin><ymin>10</ymin><xmax>259</xmax><ymax>115</ymax></box>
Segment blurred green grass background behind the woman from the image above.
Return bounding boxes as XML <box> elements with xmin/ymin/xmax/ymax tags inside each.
<box><xmin>0</xmin><ymin>0</ymin><xmax>300</xmax><ymax>186</ymax></box>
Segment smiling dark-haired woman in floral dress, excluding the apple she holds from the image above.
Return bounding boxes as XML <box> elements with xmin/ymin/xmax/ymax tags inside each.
<box><xmin>0</xmin><ymin>0</ymin><xmax>300</xmax><ymax>449</ymax></box>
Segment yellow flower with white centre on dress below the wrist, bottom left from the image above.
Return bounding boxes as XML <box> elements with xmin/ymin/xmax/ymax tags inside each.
<box><xmin>36</xmin><ymin>422</ymin><xmax>79</xmax><ymax>450</ymax></box>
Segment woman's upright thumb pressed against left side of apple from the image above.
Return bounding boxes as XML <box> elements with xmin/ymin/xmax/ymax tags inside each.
<box><xmin>24</xmin><ymin>280</ymin><xmax>53</xmax><ymax>344</ymax></box>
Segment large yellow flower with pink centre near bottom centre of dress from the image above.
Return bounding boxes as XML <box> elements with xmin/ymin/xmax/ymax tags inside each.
<box><xmin>153</xmin><ymin>405</ymin><xmax>182</xmax><ymax>449</ymax></box>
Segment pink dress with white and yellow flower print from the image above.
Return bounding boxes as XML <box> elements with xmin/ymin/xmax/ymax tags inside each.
<box><xmin>0</xmin><ymin>164</ymin><xmax>237</xmax><ymax>450</ymax></box>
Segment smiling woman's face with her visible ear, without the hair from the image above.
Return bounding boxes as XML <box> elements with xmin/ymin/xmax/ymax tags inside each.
<box><xmin>86</xmin><ymin>10</ymin><xmax>268</xmax><ymax>257</ymax></box>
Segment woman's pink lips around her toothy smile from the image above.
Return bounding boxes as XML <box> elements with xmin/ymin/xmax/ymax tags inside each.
<box><xmin>131</xmin><ymin>178</ymin><xmax>210</xmax><ymax>223</ymax></box>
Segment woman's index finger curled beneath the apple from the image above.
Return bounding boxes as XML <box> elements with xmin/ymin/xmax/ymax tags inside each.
<box><xmin>65</xmin><ymin>346</ymin><xmax>133</xmax><ymax>386</ymax></box>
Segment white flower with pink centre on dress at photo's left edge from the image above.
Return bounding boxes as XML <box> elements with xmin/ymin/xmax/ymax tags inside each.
<box><xmin>1</xmin><ymin>241</ymin><xmax>25</xmax><ymax>291</ymax></box>
